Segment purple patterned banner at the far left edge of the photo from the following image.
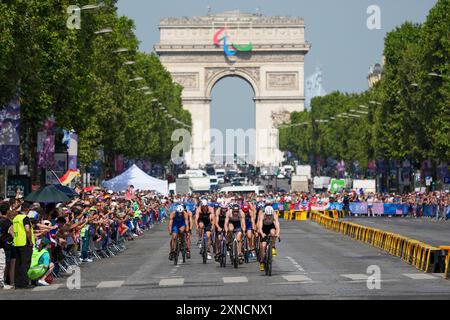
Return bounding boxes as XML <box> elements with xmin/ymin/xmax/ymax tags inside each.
<box><xmin>0</xmin><ymin>94</ymin><xmax>20</xmax><ymax>166</ymax></box>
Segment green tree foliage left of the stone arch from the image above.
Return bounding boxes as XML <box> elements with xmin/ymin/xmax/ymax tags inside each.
<box><xmin>0</xmin><ymin>0</ymin><xmax>191</xmax><ymax>179</ymax></box>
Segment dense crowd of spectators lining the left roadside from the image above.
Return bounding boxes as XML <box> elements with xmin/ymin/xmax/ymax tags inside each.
<box><xmin>0</xmin><ymin>186</ymin><xmax>169</xmax><ymax>289</ymax></box>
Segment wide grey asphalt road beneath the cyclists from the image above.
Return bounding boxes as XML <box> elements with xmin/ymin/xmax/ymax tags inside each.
<box><xmin>0</xmin><ymin>221</ymin><xmax>450</xmax><ymax>300</ymax></box>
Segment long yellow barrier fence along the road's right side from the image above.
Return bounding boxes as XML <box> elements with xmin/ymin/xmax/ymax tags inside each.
<box><xmin>309</xmin><ymin>211</ymin><xmax>450</xmax><ymax>279</ymax></box>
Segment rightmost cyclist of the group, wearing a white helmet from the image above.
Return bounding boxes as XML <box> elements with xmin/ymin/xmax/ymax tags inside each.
<box><xmin>258</xmin><ymin>205</ymin><xmax>280</xmax><ymax>271</ymax></box>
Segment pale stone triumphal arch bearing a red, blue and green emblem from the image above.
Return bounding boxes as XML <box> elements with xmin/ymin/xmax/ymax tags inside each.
<box><xmin>155</xmin><ymin>11</ymin><xmax>310</xmax><ymax>168</ymax></box>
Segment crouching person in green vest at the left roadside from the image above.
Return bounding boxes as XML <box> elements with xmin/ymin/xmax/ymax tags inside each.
<box><xmin>27</xmin><ymin>237</ymin><xmax>55</xmax><ymax>286</ymax></box>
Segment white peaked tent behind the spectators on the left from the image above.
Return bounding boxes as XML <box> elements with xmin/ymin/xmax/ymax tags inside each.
<box><xmin>102</xmin><ymin>164</ymin><xmax>169</xmax><ymax>194</ymax></box>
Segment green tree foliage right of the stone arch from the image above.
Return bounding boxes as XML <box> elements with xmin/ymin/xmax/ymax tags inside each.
<box><xmin>280</xmin><ymin>0</ymin><xmax>450</xmax><ymax>172</ymax></box>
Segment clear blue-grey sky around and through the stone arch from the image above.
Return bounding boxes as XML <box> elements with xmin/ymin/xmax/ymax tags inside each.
<box><xmin>118</xmin><ymin>0</ymin><xmax>436</xmax><ymax>159</ymax></box>
